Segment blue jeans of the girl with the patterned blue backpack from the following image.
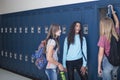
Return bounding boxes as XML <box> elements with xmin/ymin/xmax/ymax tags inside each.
<box><xmin>45</xmin><ymin>69</ymin><xmax>57</xmax><ymax>80</ymax></box>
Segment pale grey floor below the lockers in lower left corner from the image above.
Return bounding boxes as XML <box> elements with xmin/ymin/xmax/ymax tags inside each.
<box><xmin>0</xmin><ymin>68</ymin><xmax>32</xmax><ymax>80</ymax></box>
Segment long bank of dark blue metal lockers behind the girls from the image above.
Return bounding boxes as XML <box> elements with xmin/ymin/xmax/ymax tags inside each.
<box><xmin>0</xmin><ymin>0</ymin><xmax>120</xmax><ymax>80</ymax></box>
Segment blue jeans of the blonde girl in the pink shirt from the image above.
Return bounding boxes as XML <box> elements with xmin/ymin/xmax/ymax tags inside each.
<box><xmin>102</xmin><ymin>56</ymin><xmax>118</xmax><ymax>80</ymax></box>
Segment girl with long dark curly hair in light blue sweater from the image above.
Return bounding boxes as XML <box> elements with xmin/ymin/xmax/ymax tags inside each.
<box><xmin>63</xmin><ymin>21</ymin><xmax>87</xmax><ymax>80</ymax></box>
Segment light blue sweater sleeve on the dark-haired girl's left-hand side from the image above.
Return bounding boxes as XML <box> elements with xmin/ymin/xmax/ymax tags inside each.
<box><xmin>62</xmin><ymin>38</ymin><xmax>68</xmax><ymax>68</ymax></box>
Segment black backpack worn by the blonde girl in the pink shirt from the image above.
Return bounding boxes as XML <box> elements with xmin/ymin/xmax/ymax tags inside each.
<box><xmin>107</xmin><ymin>35</ymin><xmax>120</xmax><ymax>66</ymax></box>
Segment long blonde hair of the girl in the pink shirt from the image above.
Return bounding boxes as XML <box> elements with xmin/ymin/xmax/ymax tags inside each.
<box><xmin>100</xmin><ymin>17</ymin><xmax>118</xmax><ymax>41</ymax></box>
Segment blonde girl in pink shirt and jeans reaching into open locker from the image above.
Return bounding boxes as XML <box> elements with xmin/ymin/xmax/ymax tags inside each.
<box><xmin>98</xmin><ymin>5</ymin><xmax>119</xmax><ymax>80</ymax></box>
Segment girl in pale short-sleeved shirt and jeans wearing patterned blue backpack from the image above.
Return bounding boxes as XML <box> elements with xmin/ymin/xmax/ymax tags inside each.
<box><xmin>45</xmin><ymin>24</ymin><xmax>64</xmax><ymax>80</ymax></box>
